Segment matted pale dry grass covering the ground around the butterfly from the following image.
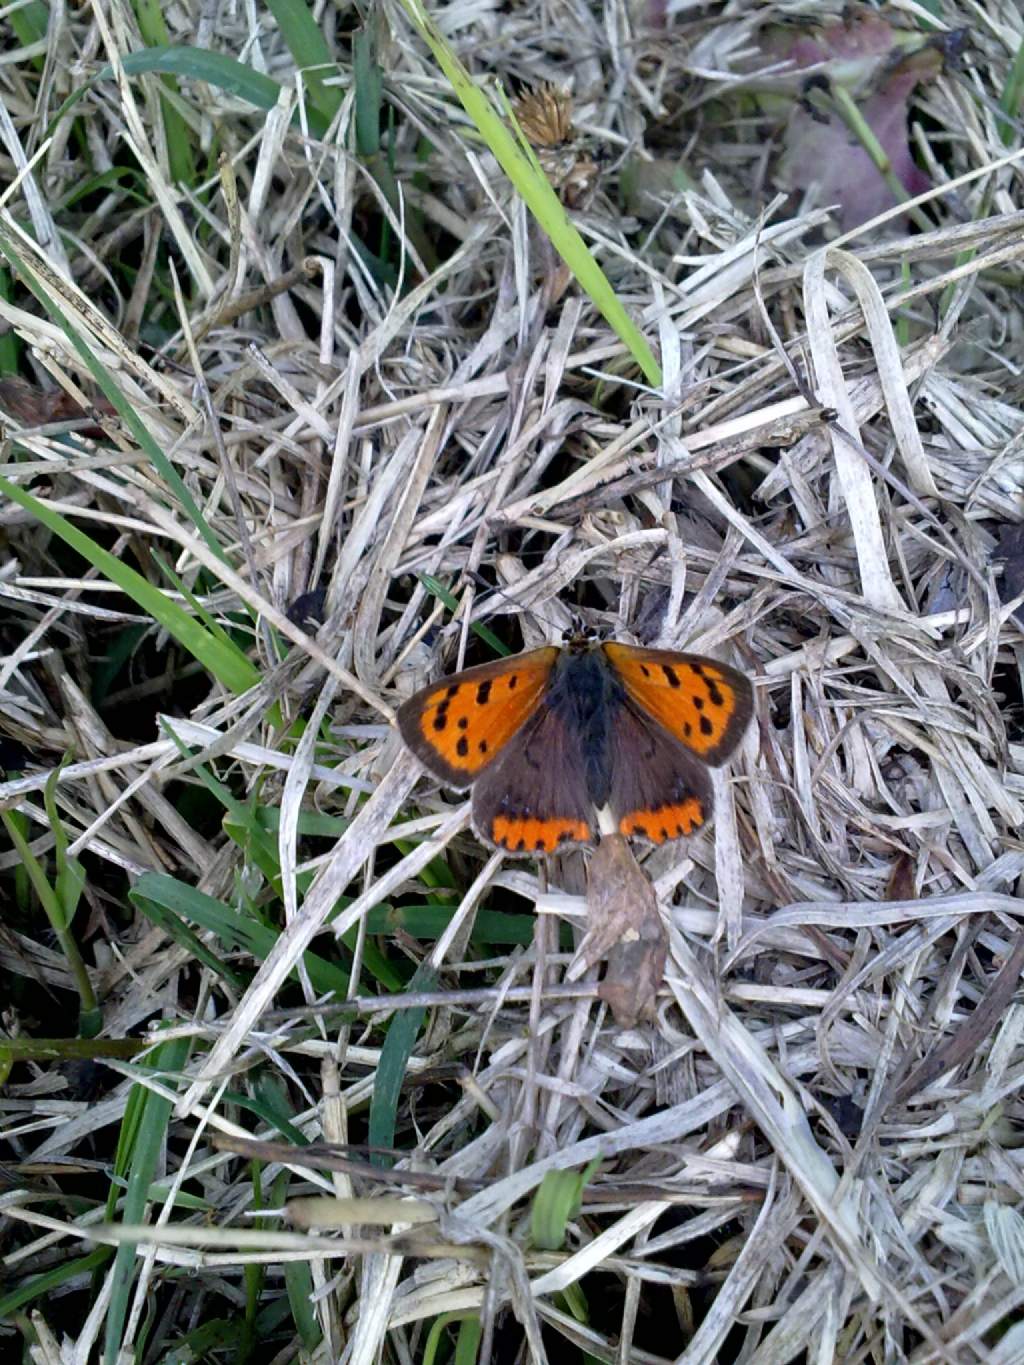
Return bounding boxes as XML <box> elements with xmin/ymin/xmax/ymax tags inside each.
<box><xmin>0</xmin><ymin>0</ymin><xmax>1024</xmax><ymax>1365</ymax></box>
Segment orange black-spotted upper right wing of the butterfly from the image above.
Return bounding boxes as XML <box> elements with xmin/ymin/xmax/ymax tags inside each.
<box><xmin>602</xmin><ymin>643</ymin><xmax>754</xmax><ymax>767</ymax></box>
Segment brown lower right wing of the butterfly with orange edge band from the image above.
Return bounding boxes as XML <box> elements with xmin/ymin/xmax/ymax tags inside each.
<box><xmin>608</xmin><ymin>700</ymin><xmax>714</xmax><ymax>844</ymax></box>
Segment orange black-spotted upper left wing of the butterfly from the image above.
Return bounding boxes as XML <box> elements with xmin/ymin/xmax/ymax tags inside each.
<box><xmin>395</xmin><ymin>646</ymin><xmax>558</xmax><ymax>789</ymax></box>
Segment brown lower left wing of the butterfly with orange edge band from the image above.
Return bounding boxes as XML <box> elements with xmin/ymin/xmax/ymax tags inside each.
<box><xmin>472</xmin><ymin>702</ymin><xmax>594</xmax><ymax>854</ymax></box>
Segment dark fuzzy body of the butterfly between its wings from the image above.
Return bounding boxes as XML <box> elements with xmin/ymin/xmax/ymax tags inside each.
<box><xmin>543</xmin><ymin>639</ymin><xmax>625</xmax><ymax>807</ymax></box>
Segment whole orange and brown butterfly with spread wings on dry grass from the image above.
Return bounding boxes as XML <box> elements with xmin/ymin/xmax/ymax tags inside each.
<box><xmin>396</xmin><ymin>636</ymin><xmax>752</xmax><ymax>854</ymax></box>
